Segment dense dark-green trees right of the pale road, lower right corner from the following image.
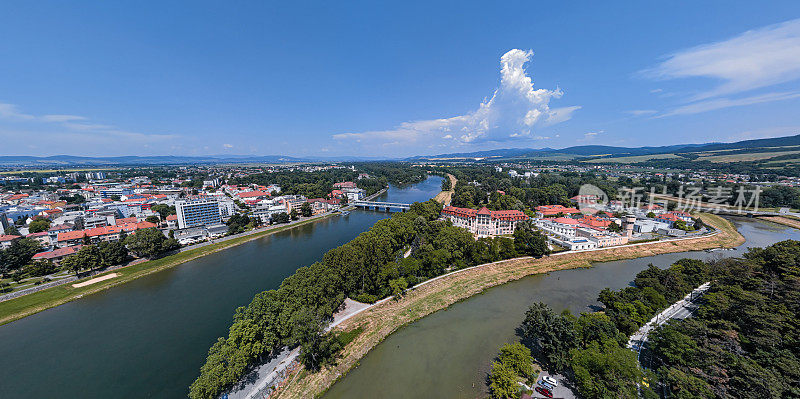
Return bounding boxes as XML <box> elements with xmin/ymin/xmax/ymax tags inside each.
<box><xmin>651</xmin><ymin>241</ymin><xmax>800</xmax><ymax>398</ymax></box>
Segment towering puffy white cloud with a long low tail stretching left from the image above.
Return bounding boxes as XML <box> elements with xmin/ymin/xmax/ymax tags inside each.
<box><xmin>333</xmin><ymin>49</ymin><xmax>581</xmax><ymax>150</ymax></box>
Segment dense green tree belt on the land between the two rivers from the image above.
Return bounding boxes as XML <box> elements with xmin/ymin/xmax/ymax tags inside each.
<box><xmin>189</xmin><ymin>201</ymin><xmax>546</xmax><ymax>398</ymax></box>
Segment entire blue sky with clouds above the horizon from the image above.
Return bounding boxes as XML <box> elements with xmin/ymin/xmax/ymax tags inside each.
<box><xmin>0</xmin><ymin>1</ymin><xmax>800</xmax><ymax>157</ymax></box>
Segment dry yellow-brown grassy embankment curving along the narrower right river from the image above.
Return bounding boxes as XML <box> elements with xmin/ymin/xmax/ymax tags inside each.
<box><xmin>278</xmin><ymin>214</ymin><xmax>744</xmax><ymax>398</ymax></box>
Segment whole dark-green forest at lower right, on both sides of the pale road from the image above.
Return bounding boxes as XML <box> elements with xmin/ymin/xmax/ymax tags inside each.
<box><xmin>489</xmin><ymin>241</ymin><xmax>800</xmax><ymax>399</ymax></box>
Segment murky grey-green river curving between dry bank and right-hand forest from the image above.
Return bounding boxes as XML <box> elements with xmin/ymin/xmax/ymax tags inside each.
<box><xmin>325</xmin><ymin>219</ymin><xmax>800</xmax><ymax>399</ymax></box>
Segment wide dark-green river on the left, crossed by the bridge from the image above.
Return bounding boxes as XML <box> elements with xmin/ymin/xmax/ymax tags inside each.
<box><xmin>0</xmin><ymin>176</ymin><xmax>441</xmax><ymax>398</ymax></box>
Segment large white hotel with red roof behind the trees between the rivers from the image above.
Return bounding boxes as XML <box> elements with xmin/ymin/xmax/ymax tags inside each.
<box><xmin>442</xmin><ymin>206</ymin><xmax>528</xmax><ymax>237</ymax></box>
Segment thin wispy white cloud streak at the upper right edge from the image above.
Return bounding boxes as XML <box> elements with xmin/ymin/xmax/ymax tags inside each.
<box><xmin>642</xmin><ymin>19</ymin><xmax>800</xmax><ymax>101</ymax></box>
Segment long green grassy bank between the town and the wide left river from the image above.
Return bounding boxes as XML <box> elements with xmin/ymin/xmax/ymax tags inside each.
<box><xmin>0</xmin><ymin>215</ymin><xmax>330</xmax><ymax>325</ymax></box>
